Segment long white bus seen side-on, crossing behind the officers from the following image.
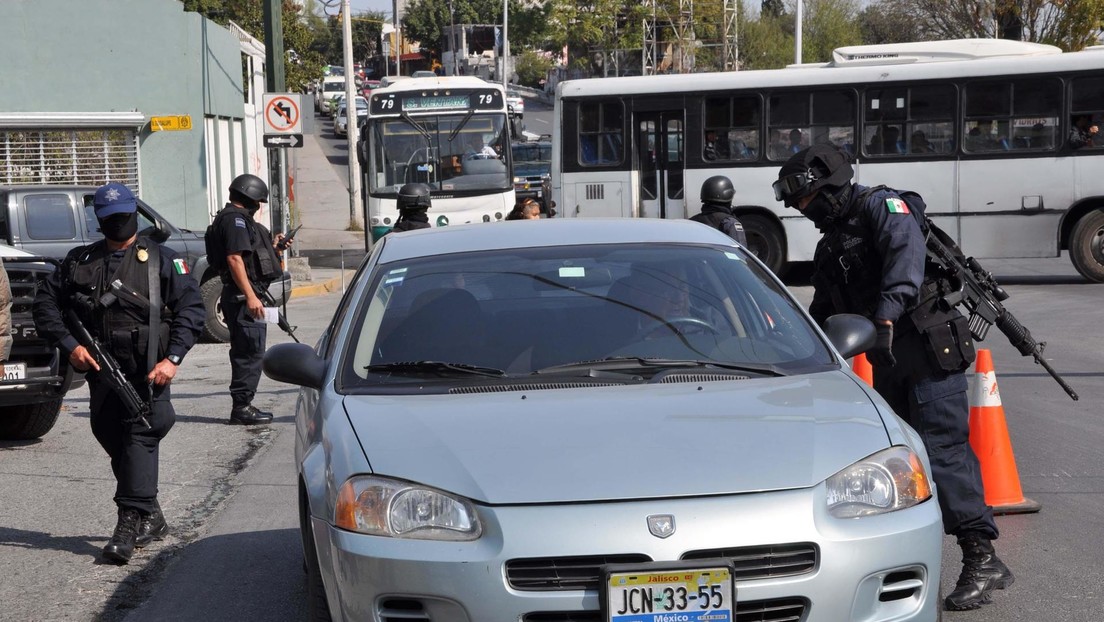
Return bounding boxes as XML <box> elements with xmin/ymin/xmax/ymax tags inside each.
<box><xmin>552</xmin><ymin>40</ymin><xmax>1104</xmax><ymax>282</ymax></box>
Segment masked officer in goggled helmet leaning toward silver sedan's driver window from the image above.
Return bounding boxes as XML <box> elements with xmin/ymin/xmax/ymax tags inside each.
<box><xmin>774</xmin><ymin>145</ymin><xmax>1013</xmax><ymax>611</ymax></box>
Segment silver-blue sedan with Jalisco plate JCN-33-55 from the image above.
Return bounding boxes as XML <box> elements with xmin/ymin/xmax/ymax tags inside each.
<box><xmin>264</xmin><ymin>219</ymin><xmax>943</xmax><ymax>622</ymax></box>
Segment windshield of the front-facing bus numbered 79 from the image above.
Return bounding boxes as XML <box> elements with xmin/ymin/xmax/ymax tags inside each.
<box><xmin>368</xmin><ymin>114</ymin><xmax>512</xmax><ymax>196</ymax></box>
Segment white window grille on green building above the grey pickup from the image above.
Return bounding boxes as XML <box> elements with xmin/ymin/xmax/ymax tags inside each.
<box><xmin>0</xmin><ymin>127</ymin><xmax>138</xmax><ymax>192</ymax></box>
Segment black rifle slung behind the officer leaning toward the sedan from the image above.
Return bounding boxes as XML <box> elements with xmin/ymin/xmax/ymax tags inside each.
<box><xmin>924</xmin><ymin>218</ymin><xmax>1078</xmax><ymax>400</ymax></box>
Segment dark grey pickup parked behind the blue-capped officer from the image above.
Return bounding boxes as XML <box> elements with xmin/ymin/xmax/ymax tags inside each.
<box><xmin>0</xmin><ymin>186</ymin><xmax>291</xmax><ymax>342</ymax></box>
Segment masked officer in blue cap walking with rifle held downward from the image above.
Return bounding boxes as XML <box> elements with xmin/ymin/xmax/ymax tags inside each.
<box><xmin>33</xmin><ymin>182</ymin><xmax>204</xmax><ymax>563</ymax></box>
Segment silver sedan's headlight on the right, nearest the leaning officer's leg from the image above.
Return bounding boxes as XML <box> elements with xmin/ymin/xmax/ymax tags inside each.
<box><xmin>825</xmin><ymin>445</ymin><xmax>932</xmax><ymax>518</ymax></box>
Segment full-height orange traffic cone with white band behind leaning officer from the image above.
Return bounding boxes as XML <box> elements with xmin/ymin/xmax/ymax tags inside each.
<box><xmin>969</xmin><ymin>350</ymin><xmax>1042</xmax><ymax>515</ymax></box>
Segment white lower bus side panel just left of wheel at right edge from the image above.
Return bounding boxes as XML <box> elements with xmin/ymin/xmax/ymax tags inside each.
<box><xmin>958</xmin><ymin>157</ymin><xmax>1075</xmax><ymax>259</ymax></box>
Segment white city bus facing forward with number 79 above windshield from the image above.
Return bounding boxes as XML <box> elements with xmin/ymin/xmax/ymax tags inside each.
<box><xmin>358</xmin><ymin>76</ymin><xmax>514</xmax><ymax>240</ymax></box>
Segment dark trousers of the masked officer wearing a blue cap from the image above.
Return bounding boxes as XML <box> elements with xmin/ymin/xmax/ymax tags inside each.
<box><xmin>88</xmin><ymin>375</ymin><xmax>177</xmax><ymax>514</ymax></box>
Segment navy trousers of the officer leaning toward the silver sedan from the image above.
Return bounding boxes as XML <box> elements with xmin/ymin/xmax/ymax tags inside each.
<box><xmin>874</xmin><ymin>321</ymin><xmax>998</xmax><ymax>539</ymax></box>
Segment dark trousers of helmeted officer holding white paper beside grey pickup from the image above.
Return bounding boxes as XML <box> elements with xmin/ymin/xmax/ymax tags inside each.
<box><xmin>222</xmin><ymin>285</ymin><xmax>268</xmax><ymax>408</ymax></box>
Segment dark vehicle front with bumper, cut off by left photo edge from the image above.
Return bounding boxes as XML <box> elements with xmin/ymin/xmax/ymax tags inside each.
<box><xmin>0</xmin><ymin>244</ymin><xmax>84</xmax><ymax>441</ymax></box>
